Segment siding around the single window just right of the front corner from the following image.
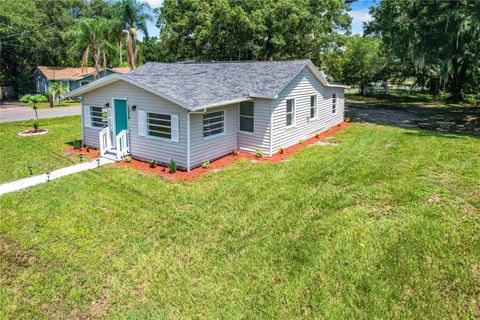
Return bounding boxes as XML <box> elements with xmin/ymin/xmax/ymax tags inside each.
<box><xmin>190</xmin><ymin>104</ymin><xmax>238</xmax><ymax>168</ymax></box>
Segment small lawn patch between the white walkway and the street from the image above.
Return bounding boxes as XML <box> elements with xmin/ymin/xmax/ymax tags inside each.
<box><xmin>0</xmin><ymin>116</ymin><xmax>82</xmax><ymax>183</ymax></box>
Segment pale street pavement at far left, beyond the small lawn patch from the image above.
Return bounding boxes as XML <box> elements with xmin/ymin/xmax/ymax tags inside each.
<box><xmin>0</xmin><ymin>102</ymin><xmax>81</xmax><ymax>123</ymax></box>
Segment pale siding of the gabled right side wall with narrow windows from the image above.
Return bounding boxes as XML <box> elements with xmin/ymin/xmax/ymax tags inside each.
<box><xmin>272</xmin><ymin>68</ymin><xmax>345</xmax><ymax>153</ymax></box>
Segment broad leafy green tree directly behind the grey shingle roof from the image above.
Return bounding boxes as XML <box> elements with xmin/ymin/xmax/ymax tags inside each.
<box><xmin>156</xmin><ymin>0</ymin><xmax>351</xmax><ymax>63</ymax></box>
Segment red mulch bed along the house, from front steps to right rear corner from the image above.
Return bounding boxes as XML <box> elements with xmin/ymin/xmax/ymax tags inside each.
<box><xmin>116</xmin><ymin>122</ymin><xmax>348</xmax><ymax>180</ymax></box>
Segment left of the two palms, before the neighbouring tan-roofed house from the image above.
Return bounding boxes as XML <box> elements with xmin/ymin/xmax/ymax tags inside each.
<box><xmin>68</xmin><ymin>18</ymin><xmax>113</xmax><ymax>80</ymax></box>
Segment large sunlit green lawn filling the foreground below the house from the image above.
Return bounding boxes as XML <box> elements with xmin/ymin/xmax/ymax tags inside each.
<box><xmin>0</xmin><ymin>119</ymin><xmax>480</xmax><ymax>319</ymax></box>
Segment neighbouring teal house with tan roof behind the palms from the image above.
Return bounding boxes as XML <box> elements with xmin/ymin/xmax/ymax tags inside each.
<box><xmin>33</xmin><ymin>66</ymin><xmax>130</xmax><ymax>94</ymax></box>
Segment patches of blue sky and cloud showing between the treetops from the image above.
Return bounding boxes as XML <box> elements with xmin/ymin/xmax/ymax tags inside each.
<box><xmin>140</xmin><ymin>0</ymin><xmax>379</xmax><ymax>36</ymax></box>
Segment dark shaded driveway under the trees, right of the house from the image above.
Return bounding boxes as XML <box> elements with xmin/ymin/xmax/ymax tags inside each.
<box><xmin>345</xmin><ymin>100</ymin><xmax>480</xmax><ymax>136</ymax></box>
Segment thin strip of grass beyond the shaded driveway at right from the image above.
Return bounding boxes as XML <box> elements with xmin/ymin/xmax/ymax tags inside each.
<box><xmin>346</xmin><ymin>92</ymin><xmax>480</xmax><ymax>107</ymax></box>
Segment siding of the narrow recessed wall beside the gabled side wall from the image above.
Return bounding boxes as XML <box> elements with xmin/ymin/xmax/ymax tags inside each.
<box><xmin>237</xmin><ymin>99</ymin><xmax>272</xmax><ymax>154</ymax></box>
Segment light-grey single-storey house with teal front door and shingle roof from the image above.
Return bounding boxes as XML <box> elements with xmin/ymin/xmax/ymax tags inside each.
<box><xmin>68</xmin><ymin>60</ymin><xmax>347</xmax><ymax>170</ymax></box>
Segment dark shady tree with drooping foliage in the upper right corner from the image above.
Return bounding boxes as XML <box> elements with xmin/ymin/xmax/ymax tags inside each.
<box><xmin>367</xmin><ymin>0</ymin><xmax>480</xmax><ymax>100</ymax></box>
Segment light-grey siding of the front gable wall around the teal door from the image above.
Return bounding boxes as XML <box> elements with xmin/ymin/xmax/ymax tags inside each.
<box><xmin>83</xmin><ymin>81</ymin><xmax>187</xmax><ymax>168</ymax></box>
